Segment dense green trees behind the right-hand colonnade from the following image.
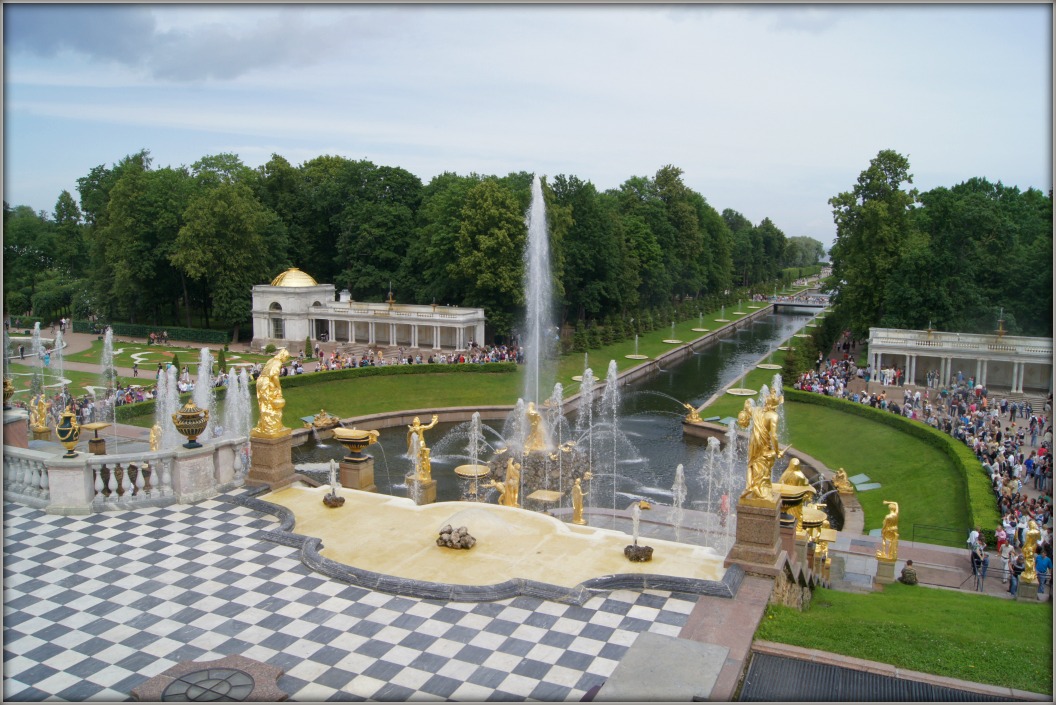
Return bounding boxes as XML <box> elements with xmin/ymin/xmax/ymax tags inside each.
<box><xmin>829</xmin><ymin>150</ymin><xmax>1053</xmax><ymax>338</ymax></box>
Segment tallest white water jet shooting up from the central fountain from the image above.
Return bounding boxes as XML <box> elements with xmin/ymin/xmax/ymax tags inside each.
<box><xmin>522</xmin><ymin>175</ymin><xmax>555</xmax><ymax>402</ymax></box>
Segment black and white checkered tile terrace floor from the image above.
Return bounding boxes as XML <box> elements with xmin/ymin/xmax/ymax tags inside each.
<box><xmin>3</xmin><ymin>497</ymin><xmax>696</xmax><ymax>702</ymax></box>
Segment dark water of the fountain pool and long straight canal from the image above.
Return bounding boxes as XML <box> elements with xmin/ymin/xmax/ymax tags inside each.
<box><xmin>294</xmin><ymin>313</ymin><xmax>810</xmax><ymax>511</ymax></box>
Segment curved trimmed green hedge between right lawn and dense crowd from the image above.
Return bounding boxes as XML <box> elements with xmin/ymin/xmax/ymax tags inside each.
<box><xmin>785</xmin><ymin>386</ymin><xmax>1001</xmax><ymax>527</ymax></box>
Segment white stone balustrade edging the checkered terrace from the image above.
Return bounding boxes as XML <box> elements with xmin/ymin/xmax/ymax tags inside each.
<box><xmin>3</xmin><ymin>437</ymin><xmax>246</xmax><ymax>514</ymax></box>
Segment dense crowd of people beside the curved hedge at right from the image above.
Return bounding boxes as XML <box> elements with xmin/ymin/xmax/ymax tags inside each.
<box><xmin>792</xmin><ymin>337</ymin><xmax>1053</xmax><ymax>594</ymax></box>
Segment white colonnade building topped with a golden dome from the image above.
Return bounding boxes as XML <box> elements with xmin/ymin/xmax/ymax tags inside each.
<box><xmin>250</xmin><ymin>267</ymin><xmax>485</xmax><ymax>351</ymax></box>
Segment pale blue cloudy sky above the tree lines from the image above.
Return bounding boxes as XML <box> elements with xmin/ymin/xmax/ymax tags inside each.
<box><xmin>3</xmin><ymin>3</ymin><xmax>1053</xmax><ymax>247</ymax></box>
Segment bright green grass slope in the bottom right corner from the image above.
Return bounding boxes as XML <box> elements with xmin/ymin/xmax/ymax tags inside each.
<box><xmin>755</xmin><ymin>583</ymin><xmax>1053</xmax><ymax>694</ymax></box>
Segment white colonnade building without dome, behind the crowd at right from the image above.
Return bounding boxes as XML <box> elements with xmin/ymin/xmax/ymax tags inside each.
<box><xmin>869</xmin><ymin>328</ymin><xmax>1053</xmax><ymax>396</ymax></box>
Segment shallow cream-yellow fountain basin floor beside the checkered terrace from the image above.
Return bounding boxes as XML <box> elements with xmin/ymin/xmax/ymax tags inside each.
<box><xmin>261</xmin><ymin>485</ymin><xmax>727</xmax><ymax>599</ymax></box>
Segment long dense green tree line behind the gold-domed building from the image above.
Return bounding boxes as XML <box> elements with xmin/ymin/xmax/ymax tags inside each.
<box><xmin>4</xmin><ymin>150</ymin><xmax>824</xmax><ymax>336</ymax></box>
